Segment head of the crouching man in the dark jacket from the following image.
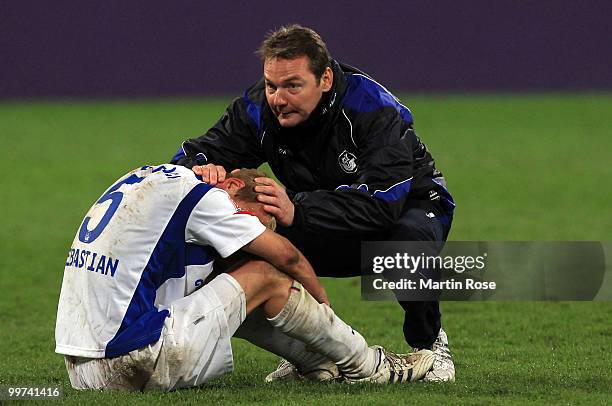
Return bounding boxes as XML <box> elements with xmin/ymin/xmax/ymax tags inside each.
<box><xmin>257</xmin><ymin>25</ymin><xmax>334</xmax><ymax>127</ymax></box>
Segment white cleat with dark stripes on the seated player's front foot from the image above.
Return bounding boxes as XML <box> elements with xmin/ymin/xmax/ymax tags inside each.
<box><xmin>346</xmin><ymin>345</ymin><xmax>435</xmax><ymax>384</ymax></box>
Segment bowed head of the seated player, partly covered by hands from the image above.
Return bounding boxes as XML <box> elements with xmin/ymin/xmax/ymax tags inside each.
<box><xmin>217</xmin><ymin>169</ymin><xmax>276</xmax><ymax>230</ymax></box>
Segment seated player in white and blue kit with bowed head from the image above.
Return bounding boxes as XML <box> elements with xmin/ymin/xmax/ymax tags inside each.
<box><xmin>55</xmin><ymin>165</ymin><xmax>434</xmax><ymax>390</ymax></box>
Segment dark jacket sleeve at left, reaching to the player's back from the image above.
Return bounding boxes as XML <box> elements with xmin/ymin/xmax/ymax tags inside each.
<box><xmin>172</xmin><ymin>94</ymin><xmax>264</xmax><ymax>171</ymax></box>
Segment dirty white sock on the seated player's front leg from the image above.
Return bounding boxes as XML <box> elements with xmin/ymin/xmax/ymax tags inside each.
<box><xmin>268</xmin><ymin>281</ymin><xmax>376</xmax><ymax>378</ymax></box>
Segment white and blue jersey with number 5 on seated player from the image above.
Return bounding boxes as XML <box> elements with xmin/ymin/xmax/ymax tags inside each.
<box><xmin>55</xmin><ymin>165</ymin><xmax>265</xmax><ymax>358</ymax></box>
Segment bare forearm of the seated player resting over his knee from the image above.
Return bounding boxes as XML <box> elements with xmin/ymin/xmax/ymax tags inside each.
<box><xmin>242</xmin><ymin>229</ymin><xmax>329</xmax><ymax>305</ymax></box>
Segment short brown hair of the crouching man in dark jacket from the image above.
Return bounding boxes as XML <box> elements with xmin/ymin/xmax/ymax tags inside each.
<box><xmin>257</xmin><ymin>24</ymin><xmax>331</xmax><ymax>82</ymax></box>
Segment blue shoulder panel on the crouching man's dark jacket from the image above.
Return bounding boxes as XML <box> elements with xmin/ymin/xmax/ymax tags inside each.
<box><xmin>343</xmin><ymin>74</ymin><xmax>413</xmax><ymax>124</ymax></box>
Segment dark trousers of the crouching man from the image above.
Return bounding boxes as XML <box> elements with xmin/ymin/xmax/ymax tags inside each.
<box><xmin>277</xmin><ymin>202</ymin><xmax>452</xmax><ymax>348</ymax></box>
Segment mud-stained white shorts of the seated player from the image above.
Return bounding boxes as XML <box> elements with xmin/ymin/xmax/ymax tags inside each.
<box><xmin>65</xmin><ymin>274</ymin><xmax>246</xmax><ymax>391</ymax></box>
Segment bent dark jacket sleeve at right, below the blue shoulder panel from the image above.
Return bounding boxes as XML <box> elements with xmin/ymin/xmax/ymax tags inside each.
<box><xmin>293</xmin><ymin>108</ymin><xmax>416</xmax><ymax>235</ymax></box>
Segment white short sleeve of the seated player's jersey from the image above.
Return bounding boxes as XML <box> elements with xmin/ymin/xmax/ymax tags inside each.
<box><xmin>185</xmin><ymin>188</ymin><xmax>266</xmax><ymax>258</ymax></box>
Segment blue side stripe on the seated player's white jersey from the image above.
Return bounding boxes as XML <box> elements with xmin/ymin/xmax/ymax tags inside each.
<box><xmin>105</xmin><ymin>183</ymin><xmax>212</xmax><ymax>358</ymax></box>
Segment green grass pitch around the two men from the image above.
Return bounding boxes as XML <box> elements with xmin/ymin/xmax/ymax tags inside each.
<box><xmin>0</xmin><ymin>93</ymin><xmax>612</xmax><ymax>405</ymax></box>
